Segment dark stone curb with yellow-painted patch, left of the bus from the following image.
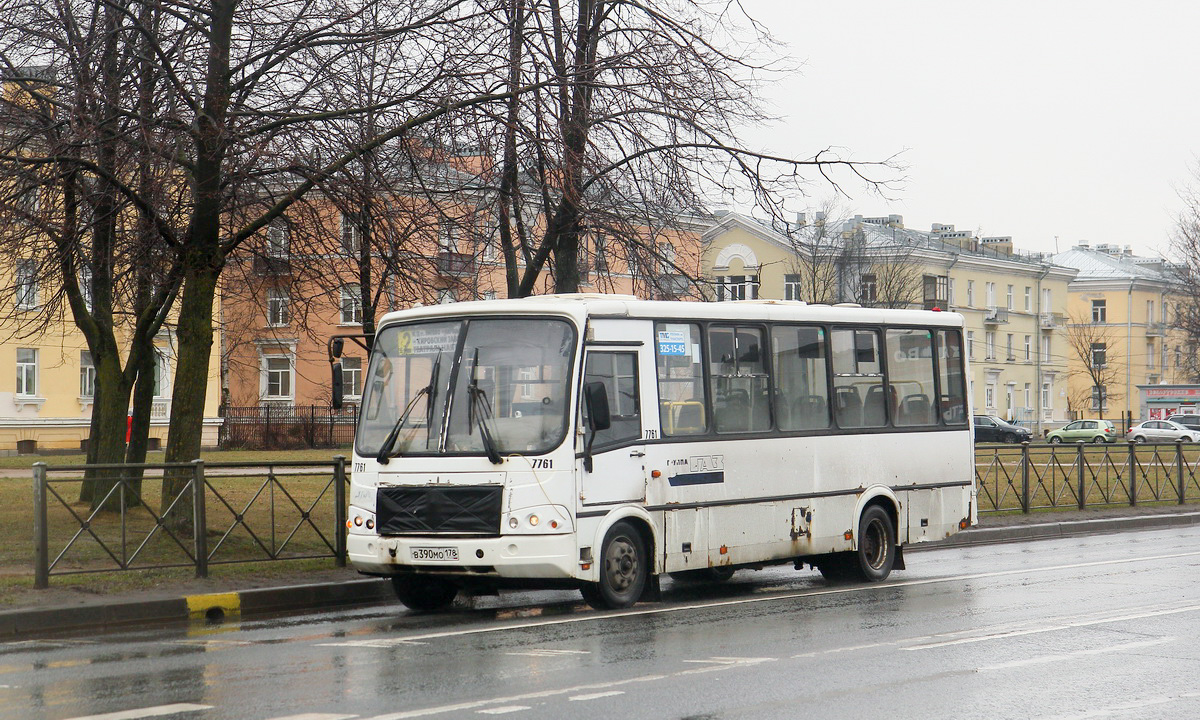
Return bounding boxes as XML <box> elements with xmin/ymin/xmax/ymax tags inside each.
<box><xmin>0</xmin><ymin>578</ymin><xmax>395</xmax><ymax>640</ymax></box>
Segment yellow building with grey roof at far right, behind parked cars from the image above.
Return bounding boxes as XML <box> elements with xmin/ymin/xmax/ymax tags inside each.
<box><xmin>1054</xmin><ymin>244</ymin><xmax>1189</xmax><ymax>422</ymax></box>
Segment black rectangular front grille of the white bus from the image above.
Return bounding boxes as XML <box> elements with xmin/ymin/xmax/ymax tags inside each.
<box><xmin>376</xmin><ymin>486</ymin><xmax>503</xmax><ymax>535</ymax></box>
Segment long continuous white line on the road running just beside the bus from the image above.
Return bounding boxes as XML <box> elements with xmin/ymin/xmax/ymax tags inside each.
<box><xmin>318</xmin><ymin>551</ymin><xmax>1200</xmax><ymax>648</ymax></box>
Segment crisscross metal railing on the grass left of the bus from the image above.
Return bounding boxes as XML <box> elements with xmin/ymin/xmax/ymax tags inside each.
<box><xmin>34</xmin><ymin>456</ymin><xmax>349</xmax><ymax>588</ymax></box>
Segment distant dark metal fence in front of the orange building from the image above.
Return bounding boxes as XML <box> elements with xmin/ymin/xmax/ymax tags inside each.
<box><xmin>217</xmin><ymin>404</ymin><xmax>358</xmax><ymax>450</ymax></box>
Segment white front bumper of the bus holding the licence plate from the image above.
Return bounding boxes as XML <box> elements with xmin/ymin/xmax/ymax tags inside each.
<box><xmin>346</xmin><ymin>533</ymin><xmax>580</xmax><ymax>580</ymax></box>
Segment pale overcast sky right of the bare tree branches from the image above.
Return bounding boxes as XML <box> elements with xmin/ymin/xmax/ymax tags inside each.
<box><xmin>743</xmin><ymin>0</ymin><xmax>1200</xmax><ymax>254</ymax></box>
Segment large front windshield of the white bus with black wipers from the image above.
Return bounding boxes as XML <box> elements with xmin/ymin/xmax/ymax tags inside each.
<box><xmin>355</xmin><ymin>318</ymin><xmax>576</xmax><ymax>462</ymax></box>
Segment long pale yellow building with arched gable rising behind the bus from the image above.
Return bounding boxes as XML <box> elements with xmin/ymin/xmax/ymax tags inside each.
<box><xmin>703</xmin><ymin>214</ymin><xmax>1075</xmax><ymax>433</ymax></box>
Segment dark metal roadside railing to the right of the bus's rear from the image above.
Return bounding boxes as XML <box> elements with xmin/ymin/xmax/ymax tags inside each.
<box><xmin>976</xmin><ymin>443</ymin><xmax>1200</xmax><ymax>512</ymax></box>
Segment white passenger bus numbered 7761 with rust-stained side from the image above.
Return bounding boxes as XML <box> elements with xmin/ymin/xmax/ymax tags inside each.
<box><xmin>334</xmin><ymin>294</ymin><xmax>977</xmax><ymax>610</ymax></box>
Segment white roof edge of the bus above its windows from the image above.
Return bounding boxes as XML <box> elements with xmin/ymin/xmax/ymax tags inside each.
<box><xmin>379</xmin><ymin>293</ymin><xmax>962</xmax><ymax>328</ymax></box>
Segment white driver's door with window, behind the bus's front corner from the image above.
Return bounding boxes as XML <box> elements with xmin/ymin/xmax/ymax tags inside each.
<box><xmin>580</xmin><ymin>342</ymin><xmax>653</xmax><ymax>509</ymax></box>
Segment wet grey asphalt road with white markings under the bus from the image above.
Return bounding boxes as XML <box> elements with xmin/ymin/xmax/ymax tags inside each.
<box><xmin>0</xmin><ymin>529</ymin><xmax>1200</xmax><ymax>720</ymax></box>
